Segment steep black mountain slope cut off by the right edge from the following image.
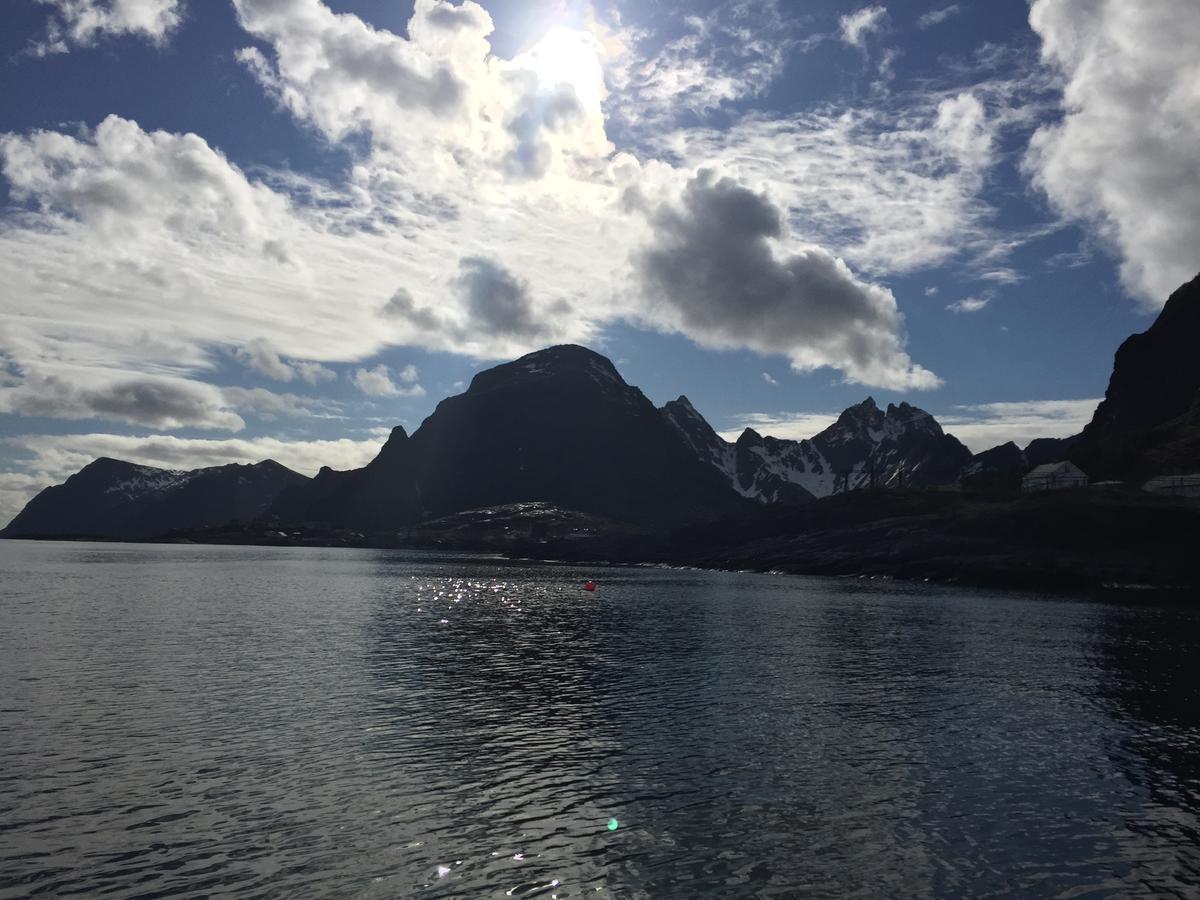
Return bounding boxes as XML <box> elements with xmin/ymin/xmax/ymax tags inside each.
<box><xmin>1070</xmin><ymin>275</ymin><xmax>1200</xmax><ymax>481</ymax></box>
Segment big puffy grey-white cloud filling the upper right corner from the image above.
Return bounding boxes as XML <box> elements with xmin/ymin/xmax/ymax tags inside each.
<box><xmin>1026</xmin><ymin>0</ymin><xmax>1200</xmax><ymax>308</ymax></box>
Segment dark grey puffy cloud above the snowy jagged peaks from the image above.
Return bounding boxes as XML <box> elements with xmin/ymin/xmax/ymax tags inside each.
<box><xmin>637</xmin><ymin>172</ymin><xmax>941</xmax><ymax>389</ymax></box>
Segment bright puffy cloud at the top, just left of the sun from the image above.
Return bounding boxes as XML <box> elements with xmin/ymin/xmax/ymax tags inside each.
<box><xmin>234</xmin><ymin>0</ymin><xmax>611</xmax><ymax>180</ymax></box>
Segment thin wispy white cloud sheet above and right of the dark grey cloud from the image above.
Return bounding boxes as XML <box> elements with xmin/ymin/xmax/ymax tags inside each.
<box><xmin>660</xmin><ymin>90</ymin><xmax>1003</xmax><ymax>274</ymax></box>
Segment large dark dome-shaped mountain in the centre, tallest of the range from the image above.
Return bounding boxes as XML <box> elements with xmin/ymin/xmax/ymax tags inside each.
<box><xmin>272</xmin><ymin>344</ymin><xmax>746</xmax><ymax>530</ymax></box>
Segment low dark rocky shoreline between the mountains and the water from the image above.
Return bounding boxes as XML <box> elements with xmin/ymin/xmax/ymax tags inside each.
<box><xmin>11</xmin><ymin>488</ymin><xmax>1200</xmax><ymax>592</ymax></box>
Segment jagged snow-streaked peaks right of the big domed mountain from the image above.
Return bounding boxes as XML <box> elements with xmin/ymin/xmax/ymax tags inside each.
<box><xmin>662</xmin><ymin>397</ymin><xmax>971</xmax><ymax>503</ymax></box>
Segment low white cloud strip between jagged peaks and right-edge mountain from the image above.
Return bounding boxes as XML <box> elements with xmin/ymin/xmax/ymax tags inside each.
<box><xmin>936</xmin><ymin>400</ymin><xmax>1100</xmax><ymax>454</ymax></box>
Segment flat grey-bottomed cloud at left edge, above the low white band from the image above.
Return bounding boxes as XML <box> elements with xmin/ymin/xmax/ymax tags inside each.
<box><xmin>0</xmin><ymin>371</ymin><xmax>245</xmax><ymax>431</ymax></box>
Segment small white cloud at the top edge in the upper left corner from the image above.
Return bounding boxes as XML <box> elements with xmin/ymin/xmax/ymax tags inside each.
<box><xmin>34</xmin><ymin>0</ymin><xmax>184</xmax><ymax>56</ymax></box>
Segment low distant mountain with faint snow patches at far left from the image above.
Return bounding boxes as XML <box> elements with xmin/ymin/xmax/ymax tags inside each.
<box><xmin>0</xmin><ymin>457</ymin><xmax>308</xmax><ymax>538</ymax></box>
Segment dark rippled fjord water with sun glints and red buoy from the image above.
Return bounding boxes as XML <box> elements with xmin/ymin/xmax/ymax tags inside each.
<box><xmin>0</xmin><ymin>541</ymin><xmax>1200</xmax><ymax>898</ymax></box>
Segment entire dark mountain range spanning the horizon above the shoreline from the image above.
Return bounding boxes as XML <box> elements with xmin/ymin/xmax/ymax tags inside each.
<box><xmin>0</xmin><ymin>276</ymin><xmax>1200</xmax><ymax>538</ymax></box>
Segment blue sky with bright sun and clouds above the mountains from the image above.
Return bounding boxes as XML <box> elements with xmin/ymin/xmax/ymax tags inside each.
<box><xmin>0</xmin><ymin>0</ymin><xmax>1200</xmax><ymax>521</ymax></box>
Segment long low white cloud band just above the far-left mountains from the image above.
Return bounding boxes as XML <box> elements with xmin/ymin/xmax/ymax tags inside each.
<box><xmin>0</xmin><ymin>433</ymin><xmax>386</xmax><ymax>523</ymax></box>
